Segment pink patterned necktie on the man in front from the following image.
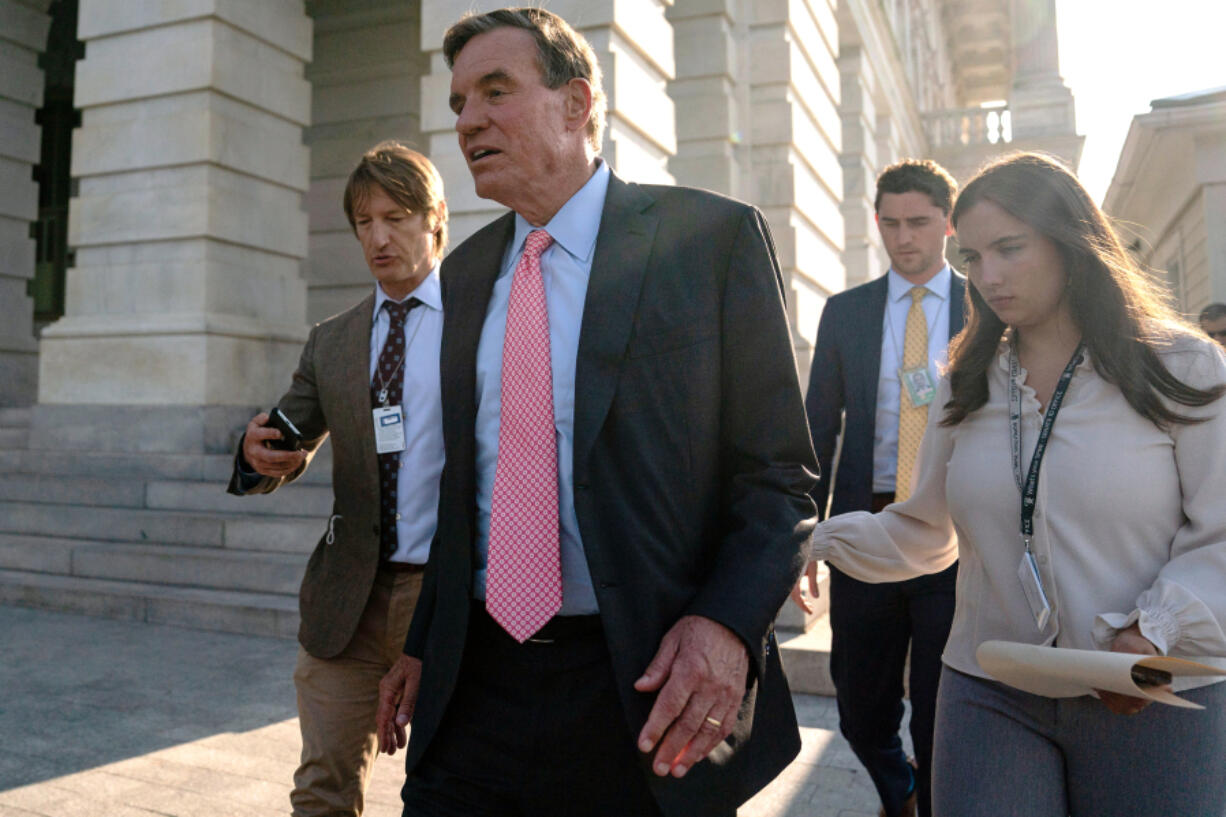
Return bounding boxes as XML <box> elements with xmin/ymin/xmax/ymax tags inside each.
<box><xmin>485</xmin><ymin>229</ymin><xmax>562</xmax><ymax>644</ymax></box>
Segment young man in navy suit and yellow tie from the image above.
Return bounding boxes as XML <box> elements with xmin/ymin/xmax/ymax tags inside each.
<box><xmin>805</xmin><ymin>159</ymin><xmax>966</xmax><ymax>817</ymax></box>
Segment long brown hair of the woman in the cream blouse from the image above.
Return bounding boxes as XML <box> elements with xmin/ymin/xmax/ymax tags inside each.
<box><xmin>942</xmin><ymin>153</ymin><xmax>1226</xmax><ymax>428</ymax></box>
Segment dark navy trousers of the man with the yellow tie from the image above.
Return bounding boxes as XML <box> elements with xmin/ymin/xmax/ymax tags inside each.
<box><xmin>830</xmin><ymin>556</ymin><xmax>958</xmax><ymax>817</ymax></box>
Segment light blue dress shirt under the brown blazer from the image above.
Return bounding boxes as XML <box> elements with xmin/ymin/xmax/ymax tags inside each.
<box><xmin>367</xmin><ymin>266</ymin><xmax>444</xmax><ymax>564</ymax></box>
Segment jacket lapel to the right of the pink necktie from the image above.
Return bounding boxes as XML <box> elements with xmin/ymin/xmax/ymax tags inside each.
<box><xmin>574</xmin><ymin>175</ymin><xmax>660</xmax><ymax>480</ymax></box>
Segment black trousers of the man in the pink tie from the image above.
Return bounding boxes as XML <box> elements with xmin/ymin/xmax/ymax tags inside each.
<box><xmin>401</xmin><ymin>602</ymin><xmax>671</xmax><ymax>817</ymax></box>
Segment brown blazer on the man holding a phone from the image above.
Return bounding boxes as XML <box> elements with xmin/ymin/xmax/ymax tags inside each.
<box><xmin>228</xmin><ymin>293</ymin><xmax>379</xmax><ymax>658</ymax></box>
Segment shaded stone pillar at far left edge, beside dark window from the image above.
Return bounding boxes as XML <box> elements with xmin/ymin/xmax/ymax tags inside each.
<box><xmin>0</xmin><ymin>0</ymin><xmax>51</xmax><ymax>406</ymax></box>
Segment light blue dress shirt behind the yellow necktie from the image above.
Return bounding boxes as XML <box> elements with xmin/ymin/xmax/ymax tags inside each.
<box><xmin>873</xmin><ymin>264</ymin><xmax>953</xmax><ymax>493</ymax></box>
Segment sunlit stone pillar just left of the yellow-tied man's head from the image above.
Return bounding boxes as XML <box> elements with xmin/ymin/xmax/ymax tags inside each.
<box><xmin>747</xmin><ymin>0</ymin><xmax>843</xmax><ymax>379</ymax></box>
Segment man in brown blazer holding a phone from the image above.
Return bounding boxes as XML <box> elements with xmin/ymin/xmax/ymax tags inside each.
<box><xmin>228</xmin><ymin>142</ymin><xmax>447</xmax><ymax>817</ymax></box>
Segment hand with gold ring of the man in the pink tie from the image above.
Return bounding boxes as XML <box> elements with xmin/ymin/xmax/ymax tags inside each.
<box><xmin>634</xmin><ymin>616</ymin><xmax>749</xmax><ymax>778</ymax></box>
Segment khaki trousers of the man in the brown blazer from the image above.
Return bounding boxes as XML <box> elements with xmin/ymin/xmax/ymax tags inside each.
<box><xmin>289</xmin><ymin>570</ymin><xmax>422</xmax><ymax>817</ymax></box>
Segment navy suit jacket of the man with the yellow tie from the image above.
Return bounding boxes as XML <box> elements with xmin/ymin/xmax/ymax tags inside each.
<box><xmin>804</xmin><ymin>272</ymin><xmax>966</xmax><ymax>518</ymax></box>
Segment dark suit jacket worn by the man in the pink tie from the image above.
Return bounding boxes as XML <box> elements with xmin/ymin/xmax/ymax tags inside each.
<box><xmin>405</xmin><ymin>170</ymin><xmax>815</xmax><ymax>817</ymax></box>
